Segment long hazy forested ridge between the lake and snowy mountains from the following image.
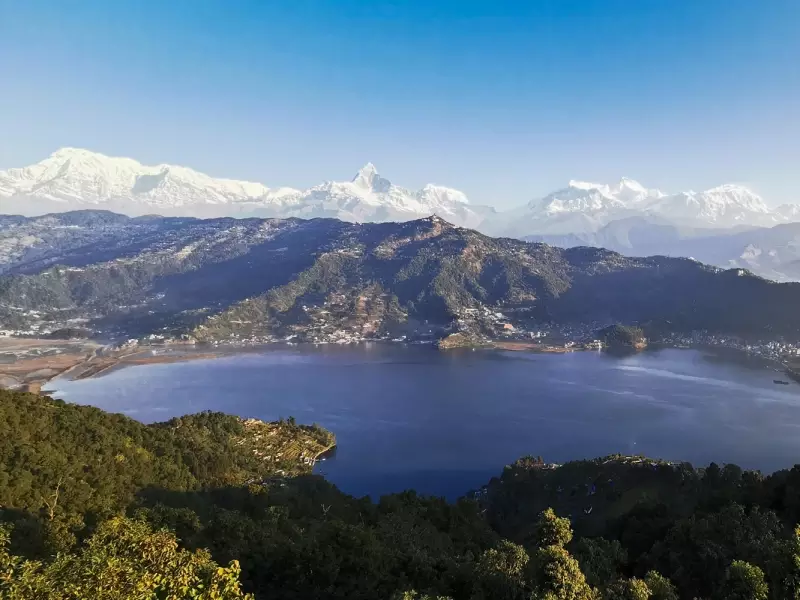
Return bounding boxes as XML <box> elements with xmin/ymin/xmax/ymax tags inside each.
<box><xmin>0</xmin><ymin>211</ymin><xmax>800</xmax><ymax>340</ymax></box>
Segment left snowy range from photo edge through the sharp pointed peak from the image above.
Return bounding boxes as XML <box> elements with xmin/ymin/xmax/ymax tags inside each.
<box><xmin>0</xmin><ymin>148</ymin><xmax>493</xmax><ymax>227</ymax></box>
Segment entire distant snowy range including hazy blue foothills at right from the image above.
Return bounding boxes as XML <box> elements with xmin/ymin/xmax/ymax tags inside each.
<box><xmin>0</xmin><ymin>148</ymin><xmax>800</xmax><ymax>281</ymax></box>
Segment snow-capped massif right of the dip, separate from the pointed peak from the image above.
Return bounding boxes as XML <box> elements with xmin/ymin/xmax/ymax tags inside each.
<box><xmin>490</xmin><ymin>178</ymin><xmax>800</xmax><ymax>237</ymax></box>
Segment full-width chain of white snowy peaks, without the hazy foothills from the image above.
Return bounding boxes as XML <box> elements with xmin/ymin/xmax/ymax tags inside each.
<box><xmin>0</xmin><ymin>148</ymin><xmax>800</xmax><ymax>237</ymax></box>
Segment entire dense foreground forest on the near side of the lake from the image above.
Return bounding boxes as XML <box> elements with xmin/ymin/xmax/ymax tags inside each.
<box><xmin>0</xmin><ymin>391</ymin><xmax>800</xmax><ymax>600</ymax></box>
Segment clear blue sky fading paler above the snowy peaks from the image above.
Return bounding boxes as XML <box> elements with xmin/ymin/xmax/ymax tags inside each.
<box><xmin>0</xmin><ymin>0</ymin><xmax>800</xmax><ymax>207</ymax></box>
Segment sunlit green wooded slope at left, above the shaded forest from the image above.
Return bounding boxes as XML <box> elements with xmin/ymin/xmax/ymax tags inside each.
<box><xmin>0</xmin><ymin>390</ymin><xmax>332</xmax><ymax>554</ymax></box>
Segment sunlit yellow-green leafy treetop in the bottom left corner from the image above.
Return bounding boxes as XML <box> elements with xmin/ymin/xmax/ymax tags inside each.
<box><xmin>0</xmin><ymin>517</ymin><xmax>252</xmax><ymax>600</ymax></box>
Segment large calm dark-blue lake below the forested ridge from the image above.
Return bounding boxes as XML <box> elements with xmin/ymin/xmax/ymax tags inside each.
<box><xmin>50</xmin><ymin>344</ymin><xmax>800</xmax><ymax>498</ymax></box>
